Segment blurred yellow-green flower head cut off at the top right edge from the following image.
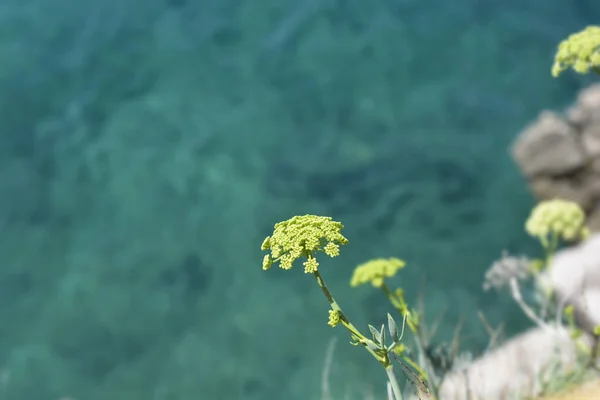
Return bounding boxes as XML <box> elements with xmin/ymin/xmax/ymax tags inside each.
<box><xmin>552</xmin><ymin>26</ymin><xmax>600</xmax><ymax>77</ymax></box>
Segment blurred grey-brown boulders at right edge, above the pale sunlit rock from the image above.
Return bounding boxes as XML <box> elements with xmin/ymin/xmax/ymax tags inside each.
<box><xmin>511</xmin><ymin>84</ymin><xmax>600</xmax><ymax>231</ymax></box>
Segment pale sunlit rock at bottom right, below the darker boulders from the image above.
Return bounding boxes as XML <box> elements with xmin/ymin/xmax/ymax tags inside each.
<box><xmin>440</xmin><ymin>234</ymin><xmax>600</xmax><ymax>400</ymax></box>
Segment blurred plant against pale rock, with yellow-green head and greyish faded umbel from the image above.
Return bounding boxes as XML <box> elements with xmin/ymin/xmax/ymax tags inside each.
<box><xmin>483</xmin><ymin>199</ymin><xmax>597</xmax><ymax>395</ymax></box>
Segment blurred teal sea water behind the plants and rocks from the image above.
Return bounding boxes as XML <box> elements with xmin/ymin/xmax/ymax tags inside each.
<box><xmin>0</xmin><ymin>0</ymin><xmax>600</xmax><ymax>400</ymax></box>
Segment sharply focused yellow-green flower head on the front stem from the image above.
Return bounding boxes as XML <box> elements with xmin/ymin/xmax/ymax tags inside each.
<box><xmin>261</xmin><ymin>215</ymin><xmax>348</xmax><ymax>273</ymax></box>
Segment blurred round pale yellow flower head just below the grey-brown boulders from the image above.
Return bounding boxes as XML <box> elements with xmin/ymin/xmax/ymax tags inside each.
<box><xmin>525</xmin><ymin>199</ymin><xmax>589</xmax><ymax>241</ymax></box>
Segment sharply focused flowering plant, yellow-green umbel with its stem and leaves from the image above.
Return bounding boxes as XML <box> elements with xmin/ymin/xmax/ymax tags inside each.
<box><xmin>261</xmin><ymin>215</ymin><xmax>420</xmax><ymax>400</ymax></box>
